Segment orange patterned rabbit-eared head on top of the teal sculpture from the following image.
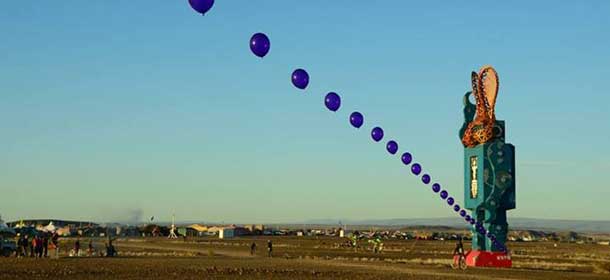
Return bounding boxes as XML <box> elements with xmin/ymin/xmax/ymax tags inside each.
<box><xmin>462</xmin><ymin>66</ymin><xmax>500</xmax><ymax>147</ymax></box>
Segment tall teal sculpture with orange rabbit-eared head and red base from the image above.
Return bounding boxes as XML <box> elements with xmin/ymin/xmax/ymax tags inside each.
<box><xmin>459</xmin><ymin>66</ymin><xmax>516</xmax><ymax>267</ymax></box>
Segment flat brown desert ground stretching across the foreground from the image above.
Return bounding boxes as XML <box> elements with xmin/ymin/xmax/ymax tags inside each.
<box><xmin>0</xmin><ymin>236</ymin><xmax>610</xmax><ymax>280</ymax></box>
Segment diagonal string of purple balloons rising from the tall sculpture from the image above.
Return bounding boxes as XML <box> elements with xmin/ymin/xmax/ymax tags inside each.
<box><xmin>189</xmin><ymin>0</ymin><xmax>507</xmax><ymax>252</ymax></box>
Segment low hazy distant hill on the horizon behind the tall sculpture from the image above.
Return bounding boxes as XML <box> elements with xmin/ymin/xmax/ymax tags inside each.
<box><xmin>303</xmin><ymin>218</ymin><xmax>610</xmax><ymax>233</ymax></box>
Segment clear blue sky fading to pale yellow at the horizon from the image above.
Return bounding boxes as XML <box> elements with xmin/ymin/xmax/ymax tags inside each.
<box><xmin>0</xmin><ymin>0</ymin><xmax>610</xmax><ymax>222</ymax></box>
